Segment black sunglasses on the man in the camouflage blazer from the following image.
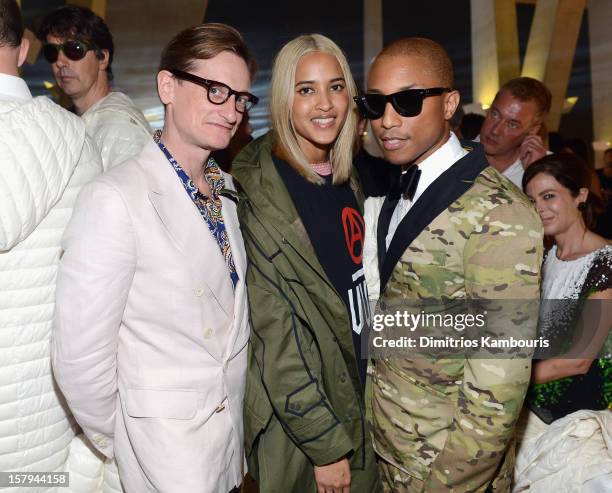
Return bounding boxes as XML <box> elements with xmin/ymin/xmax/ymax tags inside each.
<box><xmin>353</xmin><ymin>87</ymin><xmax>452</xmax><ymax>120</ymax></box>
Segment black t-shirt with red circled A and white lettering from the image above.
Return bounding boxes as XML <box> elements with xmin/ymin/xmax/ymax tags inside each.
<box><xmin>274</xmin><ymin>157</ymin><xmax>370</xmax><ymax>385</ymax></box>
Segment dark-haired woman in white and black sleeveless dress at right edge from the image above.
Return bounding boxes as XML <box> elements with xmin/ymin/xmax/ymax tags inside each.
<box><xmin>513</xmin><ymin>153</ymin><xmax>612</xmax><ymax>492</ymax></box>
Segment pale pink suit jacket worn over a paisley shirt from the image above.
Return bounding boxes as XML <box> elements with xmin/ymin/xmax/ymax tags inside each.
<box><xmin>52</xmin><ymin>140</ymin><xmax>249</xmax><ymax>493</ymax></box>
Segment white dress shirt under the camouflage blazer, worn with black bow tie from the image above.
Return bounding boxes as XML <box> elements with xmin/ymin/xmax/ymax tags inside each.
<box><xmin>386</xmin><ymin>132</ymin><xmax>468</xmax><ymax>250</ymax></box>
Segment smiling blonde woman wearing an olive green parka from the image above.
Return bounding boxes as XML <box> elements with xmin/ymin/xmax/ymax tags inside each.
<box><xmin>233</xmin><ymin>34</ymin><xmax>382</xmax><ymax>493</ymax></box>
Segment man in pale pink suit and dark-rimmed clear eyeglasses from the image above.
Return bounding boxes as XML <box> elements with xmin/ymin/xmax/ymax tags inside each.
<box><xmin>53</xmin><ymin>24</ymin><xmax>257</xmax><ymax>493</ymax></box>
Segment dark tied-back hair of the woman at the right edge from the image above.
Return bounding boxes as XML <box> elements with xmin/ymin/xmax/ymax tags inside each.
<box><xmin>523</xmin><ymin>152</ymin><xmax>603</xmax><ymax>229</ymax></box>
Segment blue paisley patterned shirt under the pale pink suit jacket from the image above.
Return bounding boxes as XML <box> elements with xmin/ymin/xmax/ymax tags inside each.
<box><xmin>153</xmin><ymin>130</ymin><xmax>239</xmax><ymax>288</ymax></box>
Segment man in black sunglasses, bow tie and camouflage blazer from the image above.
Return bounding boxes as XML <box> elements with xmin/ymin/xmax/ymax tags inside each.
<box><xmin>356</xmin><ymin>38</ymin><xmax>542</xmax><ymax>493</ymax></box>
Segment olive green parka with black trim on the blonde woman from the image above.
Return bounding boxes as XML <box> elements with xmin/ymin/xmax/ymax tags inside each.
<box><xmin>232</xmin><ymin>135</ymin><xmax>382</xmax><ymax>493</ymax></box>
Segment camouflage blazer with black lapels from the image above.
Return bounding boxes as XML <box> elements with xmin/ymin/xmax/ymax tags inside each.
<box><xmin>370</xmin><ymin>143</ymin><xmax>543</xmax><ymax>492</ymax></box>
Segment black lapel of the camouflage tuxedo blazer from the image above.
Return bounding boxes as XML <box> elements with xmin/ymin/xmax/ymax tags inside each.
<box><xmin>378</xmin><ymin>142</ymin><xmax>488</xmax><ymax>294</ymax></box>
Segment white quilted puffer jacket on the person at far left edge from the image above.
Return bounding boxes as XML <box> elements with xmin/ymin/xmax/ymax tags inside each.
<box><xmin>0</xmin><ymin>94</ymin><xmax>120</xmax><ymax>493</ymax></box>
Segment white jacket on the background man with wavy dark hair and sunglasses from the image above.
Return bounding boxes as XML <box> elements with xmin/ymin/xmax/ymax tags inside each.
<box><xmin>82</xmin><ymin>92</ymin><xmax>152</xmax><ymax>171</ymax></box>
